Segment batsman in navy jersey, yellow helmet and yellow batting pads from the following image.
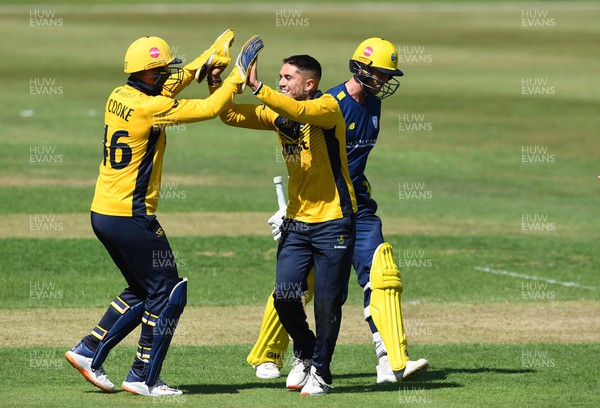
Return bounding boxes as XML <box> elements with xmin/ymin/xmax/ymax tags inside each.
<box><xmin>247</xmin><ymin>38</ymin><xmax>429</xmax><ymax>385</ymax></box>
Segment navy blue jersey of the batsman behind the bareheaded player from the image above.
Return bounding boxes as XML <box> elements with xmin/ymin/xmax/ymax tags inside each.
<box><xmin>326</xmin><ymin>84</ymin><xmax>381</xmax><ymax>211</ymax></box>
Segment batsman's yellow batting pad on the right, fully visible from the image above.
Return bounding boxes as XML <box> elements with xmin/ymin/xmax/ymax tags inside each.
<box><xmin>369</xmin><ymin>243</ymin><xmax>408</xmax><ymax>371</ymax></box>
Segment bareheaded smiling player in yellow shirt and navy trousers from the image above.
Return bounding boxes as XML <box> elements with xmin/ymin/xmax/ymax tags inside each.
<box><xmin>211</xmin><ymin>55</ymin><xmax>357</xmax><ymax>395</ymax></box>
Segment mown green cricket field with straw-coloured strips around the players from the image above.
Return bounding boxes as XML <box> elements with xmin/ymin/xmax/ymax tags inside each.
<box><xmin>0</xmin><ymin>0</ymin><xmax>600</xmax><ymax>407</ymax></box>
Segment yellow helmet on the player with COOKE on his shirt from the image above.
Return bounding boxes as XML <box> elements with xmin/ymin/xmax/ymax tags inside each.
<box><xmin>123</xmin><ymin>37</ymin><xmax>181</xmax><ymax>74</ymax></box>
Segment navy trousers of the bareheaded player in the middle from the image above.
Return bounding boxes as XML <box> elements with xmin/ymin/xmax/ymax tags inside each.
<box><xmin>273</xmin><ymin>215</ymin><xmax>355</xmax><ymax>384</ymax></box>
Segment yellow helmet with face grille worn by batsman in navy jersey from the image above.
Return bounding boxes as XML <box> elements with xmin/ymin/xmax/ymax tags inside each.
<box><xmin>349</xmin><ymin>37</ymin><xmax>404</xmax><ymax>99</ymax></box>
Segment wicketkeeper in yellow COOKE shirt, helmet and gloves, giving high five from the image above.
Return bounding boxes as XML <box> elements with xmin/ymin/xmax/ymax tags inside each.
<box><xmin>65</xmin><ymin>30</ymin><xmax>263</xmax><ymax>397</ymax></box>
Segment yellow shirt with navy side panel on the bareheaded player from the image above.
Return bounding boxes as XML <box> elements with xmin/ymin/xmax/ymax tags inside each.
<box><xmin>220</xmin><ymin>85</ymin><xmax>357</xmax><ymax>223</ymax></box>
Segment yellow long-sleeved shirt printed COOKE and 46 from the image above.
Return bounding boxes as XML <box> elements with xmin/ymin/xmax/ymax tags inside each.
<box><xmin>91</xmin><ymin>74</ymin><xmax>237</xmax><ymax>217</ymax></box>
